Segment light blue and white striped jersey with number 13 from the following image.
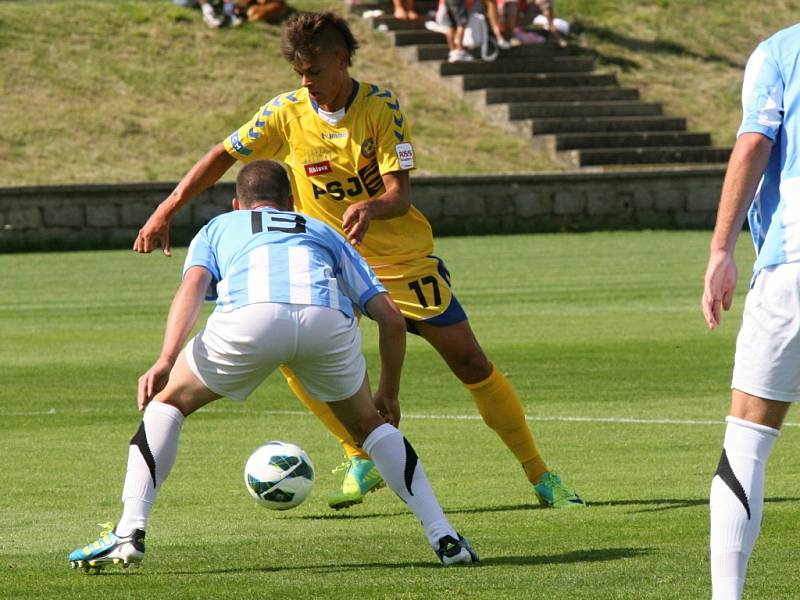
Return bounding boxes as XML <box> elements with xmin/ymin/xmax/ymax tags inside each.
<box><xmin>183</xmin><ymin>208</ymin><xmax>386</xmax><ymax>317</ymax></box>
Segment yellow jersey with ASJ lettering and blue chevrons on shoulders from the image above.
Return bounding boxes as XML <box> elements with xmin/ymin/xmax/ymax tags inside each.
<box><xmin>224</xmin><ymin>80</ymin><xmax>433</xmax><ymax>266</ymax></box>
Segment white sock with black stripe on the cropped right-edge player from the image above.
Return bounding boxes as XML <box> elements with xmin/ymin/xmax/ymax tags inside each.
<box><xmin>709</xmin><ymin>417</ymin><xmax>780</xmax><ymax>600</ymax></box>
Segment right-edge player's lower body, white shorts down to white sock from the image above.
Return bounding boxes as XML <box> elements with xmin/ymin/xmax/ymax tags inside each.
<box><xmin>710</xmin><ymin>263</ymin><xmax>800</xmax><ymax>600</ymax></box>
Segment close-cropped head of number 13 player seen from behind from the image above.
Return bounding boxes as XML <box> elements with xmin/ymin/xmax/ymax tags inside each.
<box><xmin>233</xmin><ymin>160</ymin><xmax>292</xmax><ymax>210</ymax></box>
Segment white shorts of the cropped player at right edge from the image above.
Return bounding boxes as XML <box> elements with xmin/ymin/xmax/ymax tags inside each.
<box><xmin>731</xmin><ymin>262</ymin><xmax>800</xmax><ymax>402</ymax></box>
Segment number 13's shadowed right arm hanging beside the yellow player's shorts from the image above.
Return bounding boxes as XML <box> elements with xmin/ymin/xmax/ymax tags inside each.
<box><xmin>365</xmin><ymin>294</ymin><xmax>406</xmax><ymax>427</ymax></box>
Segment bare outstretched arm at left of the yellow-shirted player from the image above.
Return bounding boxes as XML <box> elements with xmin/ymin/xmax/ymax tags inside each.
<box><xmin>133</xmin><ymin>143</ymin><xmax>236</xmax><ymax>256</ymax></box>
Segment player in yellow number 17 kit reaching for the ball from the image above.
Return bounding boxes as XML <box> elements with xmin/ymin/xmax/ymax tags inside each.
<box><xmin>134</xmin><ymin>13</ymin><xmax>584</xmax><ymax>509</ymax></box>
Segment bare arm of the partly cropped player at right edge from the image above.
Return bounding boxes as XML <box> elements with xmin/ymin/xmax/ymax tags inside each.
<box><xmin>700</xmin><ymin>133</ymin><xmax>772</xmax><ymax>329</ymax></box>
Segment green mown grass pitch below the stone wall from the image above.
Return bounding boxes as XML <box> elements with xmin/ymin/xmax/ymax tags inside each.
<box><xmin>0</xmin><ymin>232</ymin><xmax>800</xmax><ymax>600</ymax></box>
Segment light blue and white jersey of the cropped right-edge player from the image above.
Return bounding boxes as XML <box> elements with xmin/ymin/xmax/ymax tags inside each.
<box><xmin>739</xmin><ymin>25</ymin><xmax>800</xmax><ymax>280</ymax></box>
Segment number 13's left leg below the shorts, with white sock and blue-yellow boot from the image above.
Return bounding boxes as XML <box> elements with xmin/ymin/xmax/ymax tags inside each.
<box><xmin>69</xmin><ymin>351</ymin><xmax>220</xmax><ymax>570</ymax></box>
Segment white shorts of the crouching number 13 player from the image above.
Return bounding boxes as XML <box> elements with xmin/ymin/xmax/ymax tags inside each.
<box><xmin>183</xmin><ymin>302</ymin><xmax>366</xmax><ymax>402</ymax></box>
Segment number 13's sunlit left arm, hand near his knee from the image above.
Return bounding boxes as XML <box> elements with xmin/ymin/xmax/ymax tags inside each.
<box><xmin>137</xmin><ymin>267</ymin><xmax>211</xmax><ymax>410</ymax></box>
